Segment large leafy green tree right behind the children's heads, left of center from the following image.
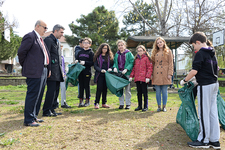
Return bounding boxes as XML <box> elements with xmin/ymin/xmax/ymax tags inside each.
<box><xmin>65</xmin><ymin>6</ymin><xmax>119</xmax><ymax>52</ymax></box>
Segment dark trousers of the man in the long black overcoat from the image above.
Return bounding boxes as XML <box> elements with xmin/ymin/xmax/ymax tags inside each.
<box><xmin>43</xmin><ymin>80</ymin><xmax>60</xmax><ymax>114</ymax></box>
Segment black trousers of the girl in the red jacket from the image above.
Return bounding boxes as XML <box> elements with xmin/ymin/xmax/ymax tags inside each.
<box><xmin>136</xmin><ymin>81</ymin><xmax>148</xmax><ymax>108</ymax></box>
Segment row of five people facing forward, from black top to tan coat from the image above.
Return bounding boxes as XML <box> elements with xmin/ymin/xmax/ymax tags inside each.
<box><xmin>75</xmin><ymin>37</ymin><xmax>173</xmax><ymax>112</ymax></box>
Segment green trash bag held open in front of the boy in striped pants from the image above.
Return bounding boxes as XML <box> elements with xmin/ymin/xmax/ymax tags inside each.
<box><xmin>176</xmin><ymin>82</ymin><xmax>199</xmax><ymax>141</ymax></box>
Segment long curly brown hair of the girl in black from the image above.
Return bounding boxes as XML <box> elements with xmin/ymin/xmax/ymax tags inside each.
<box><xmin>93</xmin><ymin>43</ymin><xmax>114</xmax><ymax>62</ymax></box>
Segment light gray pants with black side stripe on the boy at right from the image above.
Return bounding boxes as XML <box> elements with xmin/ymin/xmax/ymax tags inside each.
<box><xmin>197</xmin><ymin>83</ymin><xmax>220</xmax><ymax>143</ymax></box>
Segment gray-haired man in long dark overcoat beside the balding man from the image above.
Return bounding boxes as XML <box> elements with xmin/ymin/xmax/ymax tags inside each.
<box><xmin>43</xmin><ymin>24</ymin><xmax>65</xmax><ymax>117</ymax></box>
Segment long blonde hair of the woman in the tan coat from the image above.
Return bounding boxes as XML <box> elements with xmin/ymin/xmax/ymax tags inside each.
<box><xmin>151</xmin><ymin>37</ymin><xmax>170</xmax><ymax>63</ymax></box>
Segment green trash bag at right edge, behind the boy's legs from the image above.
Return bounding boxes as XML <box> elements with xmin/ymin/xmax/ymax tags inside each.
<box><xmin>217</xmin><ymin>90</ymin><xmax>225</xmax><ymax>130</ymax></box>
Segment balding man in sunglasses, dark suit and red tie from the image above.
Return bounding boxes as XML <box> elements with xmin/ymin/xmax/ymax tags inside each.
<box><xmin>18</xmin><ymin>20</ymin><xmax>51</xmax><ymax>127</ymax></box>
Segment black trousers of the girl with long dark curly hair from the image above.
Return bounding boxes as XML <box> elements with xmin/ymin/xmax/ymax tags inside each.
<box><xmin>95</xmin><ymin>73</ymin><xmax>107</xmax><ymax>104</ymax></box>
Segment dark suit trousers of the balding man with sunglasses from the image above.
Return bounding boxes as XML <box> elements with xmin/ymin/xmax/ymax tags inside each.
<box><xmin>24</xmin><ymin>68</ymin><xmax>48</xmax><ymax>124</ymax></box>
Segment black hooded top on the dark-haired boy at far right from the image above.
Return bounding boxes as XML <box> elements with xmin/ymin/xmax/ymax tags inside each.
<box><xmin>192</xmin><ymin>47</ymin><xmax>218</xmax><ymax>85</ymax></box>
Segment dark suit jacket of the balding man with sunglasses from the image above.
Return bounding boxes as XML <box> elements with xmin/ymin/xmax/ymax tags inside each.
<box><xmin>18</xmin><ymin>31</ymin><xmax>51</xmax><ymax>78</ymax></box>
